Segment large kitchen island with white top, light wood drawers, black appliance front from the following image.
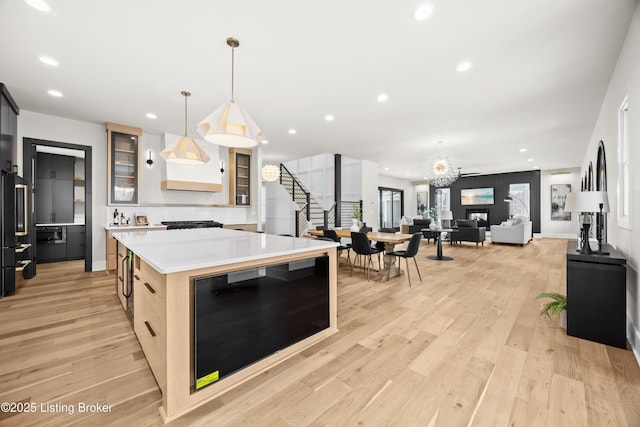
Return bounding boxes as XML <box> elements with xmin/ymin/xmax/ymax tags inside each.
<box><xmin>114</xmin><ymin>228</ymin><xmax>337</xmax><ymax>422</ymax></box>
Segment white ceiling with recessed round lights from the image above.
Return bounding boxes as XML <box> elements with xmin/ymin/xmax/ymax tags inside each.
<box><xmin>0</xmin><ymin>0</ymin><xmax>638</xmax><ymax>180</ymax></box>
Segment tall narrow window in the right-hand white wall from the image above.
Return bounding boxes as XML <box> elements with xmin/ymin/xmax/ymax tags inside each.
<box><xmin>618</xmin><ymin>96</ymin><xmax>631</xmax><ymax>230</ymax></box>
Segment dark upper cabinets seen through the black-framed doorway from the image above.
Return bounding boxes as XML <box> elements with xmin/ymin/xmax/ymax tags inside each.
<box><xmin>35</xmin><ymin>153</ymin><xmax>75</xmax><ymax>224</ymax></box>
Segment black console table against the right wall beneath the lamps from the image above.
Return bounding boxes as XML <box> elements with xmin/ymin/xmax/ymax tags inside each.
<box><xmin>567</xmin><ymin>241</ymin><xmax>626</xmax><ymax>348</ymax></box>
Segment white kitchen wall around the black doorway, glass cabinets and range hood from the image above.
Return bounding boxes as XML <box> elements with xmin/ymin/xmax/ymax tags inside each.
<box><xmin>18</xmin><ymin>110</ymin><xmax>261</xmax><ymax>271</ymax></box>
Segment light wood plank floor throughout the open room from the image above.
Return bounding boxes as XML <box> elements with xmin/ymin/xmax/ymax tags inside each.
<box><xmin>0</xmin><ymin>239</ymin><xmax>640</xmax><ymax>426</ymax></box>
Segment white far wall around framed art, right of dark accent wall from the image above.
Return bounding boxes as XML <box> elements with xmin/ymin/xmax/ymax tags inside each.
<box><xmin>540</xmin><ymin>168</ymin><xmax>582</xmax><ymax>239</ymax></box>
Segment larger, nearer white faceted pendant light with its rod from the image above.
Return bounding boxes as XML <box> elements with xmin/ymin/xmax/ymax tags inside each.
<box><xmin>198</xmin><ymin>37</ymin><xmax>264</xmax><ymax>148</ymax></box>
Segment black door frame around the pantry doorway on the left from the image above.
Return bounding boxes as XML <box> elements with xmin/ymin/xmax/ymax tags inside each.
<box><xmin>22</xmin><ymin>137</ymin><xmax>93</xmax><ymax>275</ymax></box>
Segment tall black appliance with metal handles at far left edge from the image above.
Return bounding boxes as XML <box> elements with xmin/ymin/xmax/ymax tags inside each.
<box><xmin>0</xmin><ymin>171</ymin><xmax>32</xmax><ymax>298</ymax></box>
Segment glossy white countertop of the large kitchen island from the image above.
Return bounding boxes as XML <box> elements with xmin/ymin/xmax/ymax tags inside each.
<box><xmin>113</xmin><ymin>228</ymin><xmax>338</xmax><ymax>274</ymax></box>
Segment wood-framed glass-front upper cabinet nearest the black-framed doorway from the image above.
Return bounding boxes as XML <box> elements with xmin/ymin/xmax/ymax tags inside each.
<box><xmin>107</xmin><ymin>123</ymin><xmax>142</xmax><ymax>204</ymax></box>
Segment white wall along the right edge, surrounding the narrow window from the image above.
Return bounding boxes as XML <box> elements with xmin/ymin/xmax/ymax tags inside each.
<box><xmin>582</xmin><ymin>2</ymin><xmax>640</xmax><ymax>361</ymax></box>
